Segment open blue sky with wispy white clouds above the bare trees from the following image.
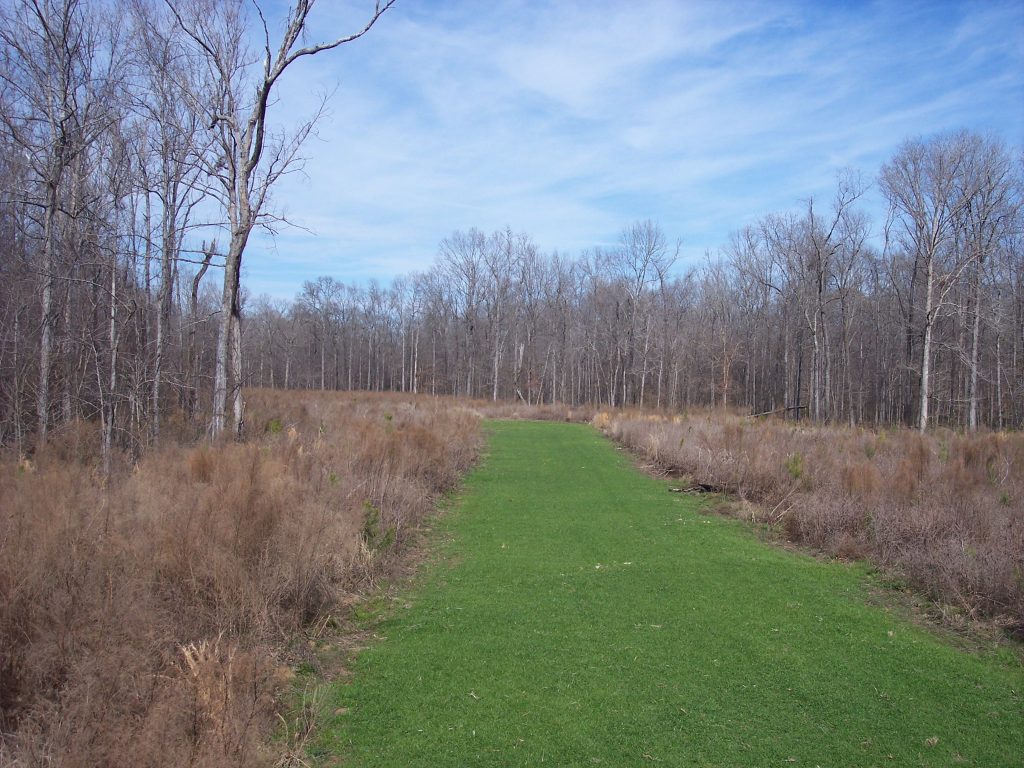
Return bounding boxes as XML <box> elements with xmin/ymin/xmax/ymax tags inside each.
<box><xmin>244</xmin><ymin>0</ymin><xmax>1024</xmax><ymax>299</ymax></box>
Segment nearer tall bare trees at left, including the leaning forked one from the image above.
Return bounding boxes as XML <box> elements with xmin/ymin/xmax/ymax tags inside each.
<box><xmin>0</xmin><ymin>0</ymin><xmax>394</xmax><ymax>459</ymax></box>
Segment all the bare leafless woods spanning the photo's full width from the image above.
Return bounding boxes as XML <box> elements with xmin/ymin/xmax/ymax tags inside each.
<box><xmin>0</xmin><ymin>0</ymin><xmax>1024</xmax><ymax>463</ymax></box>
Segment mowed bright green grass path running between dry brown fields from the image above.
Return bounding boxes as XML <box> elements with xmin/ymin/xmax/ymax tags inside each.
<box><xmin>312</xmin><ymin>422</ymin><xmax>1024</xmax><ymax>767</ymax></box>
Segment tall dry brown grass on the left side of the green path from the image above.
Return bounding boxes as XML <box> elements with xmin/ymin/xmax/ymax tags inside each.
<box><xmin>0</xmin><ymin>391</ymin><xmax>478</xmax><ymax>767</ymax></box>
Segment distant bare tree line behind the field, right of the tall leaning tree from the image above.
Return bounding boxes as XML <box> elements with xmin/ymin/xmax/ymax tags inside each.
<box><xmin>245</xmin><ymin>141</ymin><xmax>1024</xmax><ymax>436</ymax></box>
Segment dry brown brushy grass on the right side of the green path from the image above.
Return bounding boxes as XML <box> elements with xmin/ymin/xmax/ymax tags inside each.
<box><xmin>595</xmin><ymin>412</ymin><xmax>1024</xmax><ymax>633</ymax></box>
